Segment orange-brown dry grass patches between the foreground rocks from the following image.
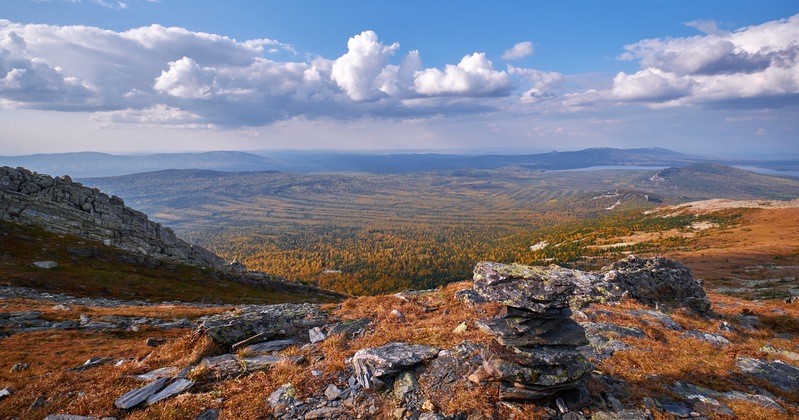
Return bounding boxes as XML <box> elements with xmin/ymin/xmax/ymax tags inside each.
<box><xmin>0</xmin><ymin>283</ymin><xmax>799</xmax><ymax>419</ymax></box>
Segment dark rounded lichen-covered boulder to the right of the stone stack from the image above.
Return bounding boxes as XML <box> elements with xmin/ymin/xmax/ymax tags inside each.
<box><xmin>602</xmin><ymin>255</ymin><xmax>710</xmax><ymax>313</ymax></box>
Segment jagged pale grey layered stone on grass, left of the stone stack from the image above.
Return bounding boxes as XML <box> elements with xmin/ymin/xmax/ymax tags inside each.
<box><xmin>352</xmin><ymin>342</ymin><xmax>439</xmax><ymax>389</ymax></box>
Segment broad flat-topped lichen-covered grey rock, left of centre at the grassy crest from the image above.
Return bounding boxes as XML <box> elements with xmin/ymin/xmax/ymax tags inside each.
<box><xmin>198</xmin><ymin>303</ymin><xmax>328</xmax><ymax>347</ymax></box>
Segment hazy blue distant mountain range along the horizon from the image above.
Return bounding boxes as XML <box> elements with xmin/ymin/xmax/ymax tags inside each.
<box><xmin>0</xmin><ymin>147</ymin><xmax>799</xmax><ymax>178</ymax></box>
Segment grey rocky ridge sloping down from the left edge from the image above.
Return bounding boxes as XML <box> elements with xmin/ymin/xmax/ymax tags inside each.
<box><xmin>0</xmin><ymin>166</ymin><xmax>226</xmax><ymax>269</ymax></box>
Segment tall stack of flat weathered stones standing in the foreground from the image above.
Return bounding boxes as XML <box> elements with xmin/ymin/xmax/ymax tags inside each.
<box><xmin>474</xmin><ymin>262</ymin><xmax>593</xmax><ymax>400</ymax></box>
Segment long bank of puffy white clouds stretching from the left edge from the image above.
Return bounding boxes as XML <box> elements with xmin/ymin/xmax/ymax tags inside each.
<box><xmin>0</xmin><ymin>20</ymin><xmax>562</xmax><ymax>127</ymax></box>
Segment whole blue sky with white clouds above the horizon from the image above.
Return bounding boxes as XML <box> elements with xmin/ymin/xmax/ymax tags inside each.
<box><xmin>0</xmin><ymin>0</ymin><xmax>799</xmax><ymax>158</ymax></box>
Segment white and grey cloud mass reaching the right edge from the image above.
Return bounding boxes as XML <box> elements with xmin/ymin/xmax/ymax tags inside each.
<box><xmin>568</xmin><ymin>15</ymin><xmax>799</xmax><ymax>107</ymax></box>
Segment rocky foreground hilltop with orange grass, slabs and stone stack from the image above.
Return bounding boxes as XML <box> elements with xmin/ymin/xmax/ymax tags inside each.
<box><xmin>0</xmin><ymin>256</ymin><xmax>799</xmax><ymax>419</ymax></box>
